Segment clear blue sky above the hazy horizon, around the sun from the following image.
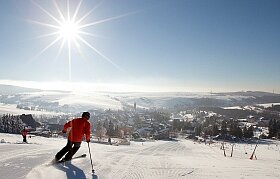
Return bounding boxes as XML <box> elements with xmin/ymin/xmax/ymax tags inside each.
<box><xmin>0</xmin><ymin>0</ymin><xmax>280</xmax><ymax>93</ymax></box>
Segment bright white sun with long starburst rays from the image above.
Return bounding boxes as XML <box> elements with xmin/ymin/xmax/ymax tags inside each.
<box><xmin>29</xmin><ymin>0</ymin><xmax>130</xmax><ymax>81</ymax></box>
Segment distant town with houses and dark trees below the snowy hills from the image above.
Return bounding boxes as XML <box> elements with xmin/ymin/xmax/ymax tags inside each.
<box><xmin>0</xmin><ymin>103</ymin><xmax>280</xmax><ymax>142</ymax></box>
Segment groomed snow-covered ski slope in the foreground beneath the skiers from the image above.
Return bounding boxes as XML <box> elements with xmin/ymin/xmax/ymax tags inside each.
<box><xmin>0</xmin><ymin>133</ymin><xmax>280</xmax><ymax>179</ymax></box>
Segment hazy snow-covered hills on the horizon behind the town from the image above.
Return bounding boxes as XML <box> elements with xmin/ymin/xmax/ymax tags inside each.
<box><xmin>0</xmin><ymin>84</ymin><xmax>280</xmax><ymax>114</ymax></box>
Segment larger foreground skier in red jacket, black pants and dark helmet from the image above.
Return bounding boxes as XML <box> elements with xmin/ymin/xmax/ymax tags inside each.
<box><xmin>54</xmin><ymin>112</ymin><xmax>90</xmax><ymax>162</ymax></box>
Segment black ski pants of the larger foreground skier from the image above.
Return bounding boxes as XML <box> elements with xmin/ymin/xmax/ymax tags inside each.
<box><xmin>55</xmin><ymin>140</ymin><xmax>81</xmax><ymax>160</ymax></box>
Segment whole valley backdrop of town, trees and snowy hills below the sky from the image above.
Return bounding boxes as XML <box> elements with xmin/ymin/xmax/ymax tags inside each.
<box><xmin>0</xmin><ymin>85</ymin><xmax>280</xmax><ymax>142</ymax></box>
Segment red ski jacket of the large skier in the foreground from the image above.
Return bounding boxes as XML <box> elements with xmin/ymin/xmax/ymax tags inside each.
<box><xmin>63</xmin><ymin>118</ymin><xmax>90</xmax><ymax>142</ymax></box>
